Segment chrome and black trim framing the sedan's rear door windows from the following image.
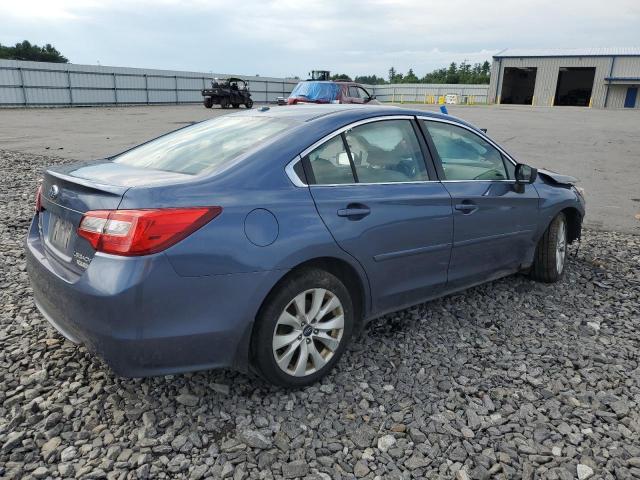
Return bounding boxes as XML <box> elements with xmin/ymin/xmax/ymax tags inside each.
<box><xmin>285</xmin><ymin>115</ymin><xmax>440</xmax><ymax>188</ymax></box>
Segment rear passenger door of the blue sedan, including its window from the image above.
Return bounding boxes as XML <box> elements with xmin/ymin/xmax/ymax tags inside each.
<box><xmin>303</xmin><ymin>116</ymin><xmax>453</xmax><ymax>312</ymax></box>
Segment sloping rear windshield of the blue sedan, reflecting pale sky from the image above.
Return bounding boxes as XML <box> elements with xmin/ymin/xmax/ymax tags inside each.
<box><xmin>113</xmin><ymin>116</ymin><xmax>292</xmax><ymax>175</ymax></box>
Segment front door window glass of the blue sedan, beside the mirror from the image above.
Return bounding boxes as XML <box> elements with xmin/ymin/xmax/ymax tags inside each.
<box><xmin>424</xmin><ymin>121</ymin><xmax>509</xmax><ymax>180</ymax></box>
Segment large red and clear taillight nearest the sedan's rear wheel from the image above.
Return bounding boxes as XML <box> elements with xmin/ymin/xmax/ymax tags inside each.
<box><xmin>78</xmin><ymin>207</ymin><xmax>222</xmax><ymax>256</ymax></box>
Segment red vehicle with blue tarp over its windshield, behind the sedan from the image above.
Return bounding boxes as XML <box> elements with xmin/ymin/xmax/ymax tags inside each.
<box><xmin>287</xmin><ymin>80</ymin><xmax>380</xmax><ymax>105</ymax></box>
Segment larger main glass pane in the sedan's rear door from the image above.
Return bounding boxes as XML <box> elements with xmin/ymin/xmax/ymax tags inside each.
<box><xmin>345</xmin><ymin>120</ymin><xmax>428</xmax><ymax>183</ymax></box>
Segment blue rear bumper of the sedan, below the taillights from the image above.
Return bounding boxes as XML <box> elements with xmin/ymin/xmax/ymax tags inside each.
<box><xmin>26</xmin><ymin>216</ymin><xmax>282</xmax><ymax>377</ymax></box>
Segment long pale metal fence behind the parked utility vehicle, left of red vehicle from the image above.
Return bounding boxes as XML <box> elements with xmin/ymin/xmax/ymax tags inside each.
<box><xmin>0</xmin><ymin>60</ymin><xmax>298</xmax><ymax>107</ymax></box>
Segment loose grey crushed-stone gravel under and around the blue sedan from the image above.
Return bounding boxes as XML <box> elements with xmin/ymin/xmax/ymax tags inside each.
<box><xmin>0</xmin><ymin>151</ymin><xmax>640</xmax><ymax>480</ymax></box>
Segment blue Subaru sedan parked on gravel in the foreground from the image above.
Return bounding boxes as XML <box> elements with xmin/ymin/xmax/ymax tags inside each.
<box><xmin>26</xmin><ymin>105</ymin><xmax>585</xmax><ymax>387</ymax></box>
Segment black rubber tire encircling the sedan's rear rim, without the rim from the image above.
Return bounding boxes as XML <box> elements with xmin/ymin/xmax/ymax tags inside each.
<box><xmin>251</xmin><ymin>270</ymin><xmax>355</xmax><ymax>388</ymax></box>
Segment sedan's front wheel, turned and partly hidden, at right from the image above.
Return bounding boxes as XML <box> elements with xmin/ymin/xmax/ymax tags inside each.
<box><xmin>530</xmin><ymin>213</ymin><xmax>567</xmax><ymax>283</ymax></box>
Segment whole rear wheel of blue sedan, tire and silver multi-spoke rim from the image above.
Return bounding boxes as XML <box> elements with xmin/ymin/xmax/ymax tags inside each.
<box><xmin>251</xmin><ymin>269</ymin><xmax>354</xmax><ymax>388</ymax></box>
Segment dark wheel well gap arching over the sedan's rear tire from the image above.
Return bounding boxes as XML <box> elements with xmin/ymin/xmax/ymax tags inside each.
<box><xmin>257</xmin><ymin>257</ymin><xmax>366</xmax><ymax>331</ymax></box>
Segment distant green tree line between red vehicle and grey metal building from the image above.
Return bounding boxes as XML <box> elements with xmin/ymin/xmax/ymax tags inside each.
<box><xmin>331</xmin><ymin>61</ymin><xmax>491</xmax><ymax>85</ymax></box>
